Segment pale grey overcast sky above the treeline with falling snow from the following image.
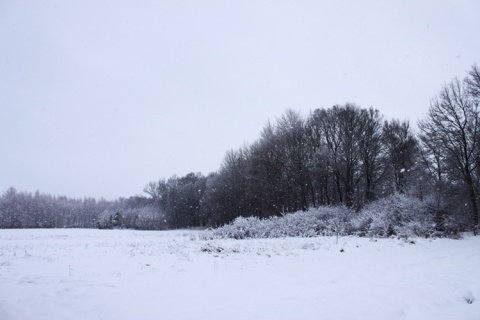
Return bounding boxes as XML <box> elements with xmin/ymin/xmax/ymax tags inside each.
<box><xmin>0</xmin><ymin>0</ymin><xmax>480</xmax><ymax>199</ymax></box>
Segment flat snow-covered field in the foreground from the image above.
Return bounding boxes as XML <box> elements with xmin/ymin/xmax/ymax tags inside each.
<box><xmin>0</xmin><ymin>229</ymin><xmax>480</xmax><ymax>320</ymax></box>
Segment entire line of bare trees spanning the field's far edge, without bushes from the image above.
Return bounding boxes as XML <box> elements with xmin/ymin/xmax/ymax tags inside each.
<box><xmin>0</xmin><ymin>65</ymin><xmax>480</xmax><ymax>231</ymax></box>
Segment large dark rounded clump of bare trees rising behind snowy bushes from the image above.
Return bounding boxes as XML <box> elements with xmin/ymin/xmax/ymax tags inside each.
<box><xmin>191</xmin><ymin>104</ymin><xmax>418</xmax><ymax>224</ymax></box>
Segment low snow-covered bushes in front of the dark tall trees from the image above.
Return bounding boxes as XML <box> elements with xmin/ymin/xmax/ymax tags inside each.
<box><xmin>213</xmin><ymin>194</ymin><xmax>438</xmax><ymax>239</ymax></box>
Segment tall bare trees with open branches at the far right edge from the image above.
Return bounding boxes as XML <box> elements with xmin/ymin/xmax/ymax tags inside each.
<box><xmin>418</xmin><ymin>65</ymin><xmax>480</xmax><ymax>232</ymax></box>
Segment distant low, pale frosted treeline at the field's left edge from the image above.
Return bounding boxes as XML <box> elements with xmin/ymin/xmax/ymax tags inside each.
<box><xmin>0</xmin><ymin>188</ymin><xmax>167</xmax><ymax>229</ymax></box>
